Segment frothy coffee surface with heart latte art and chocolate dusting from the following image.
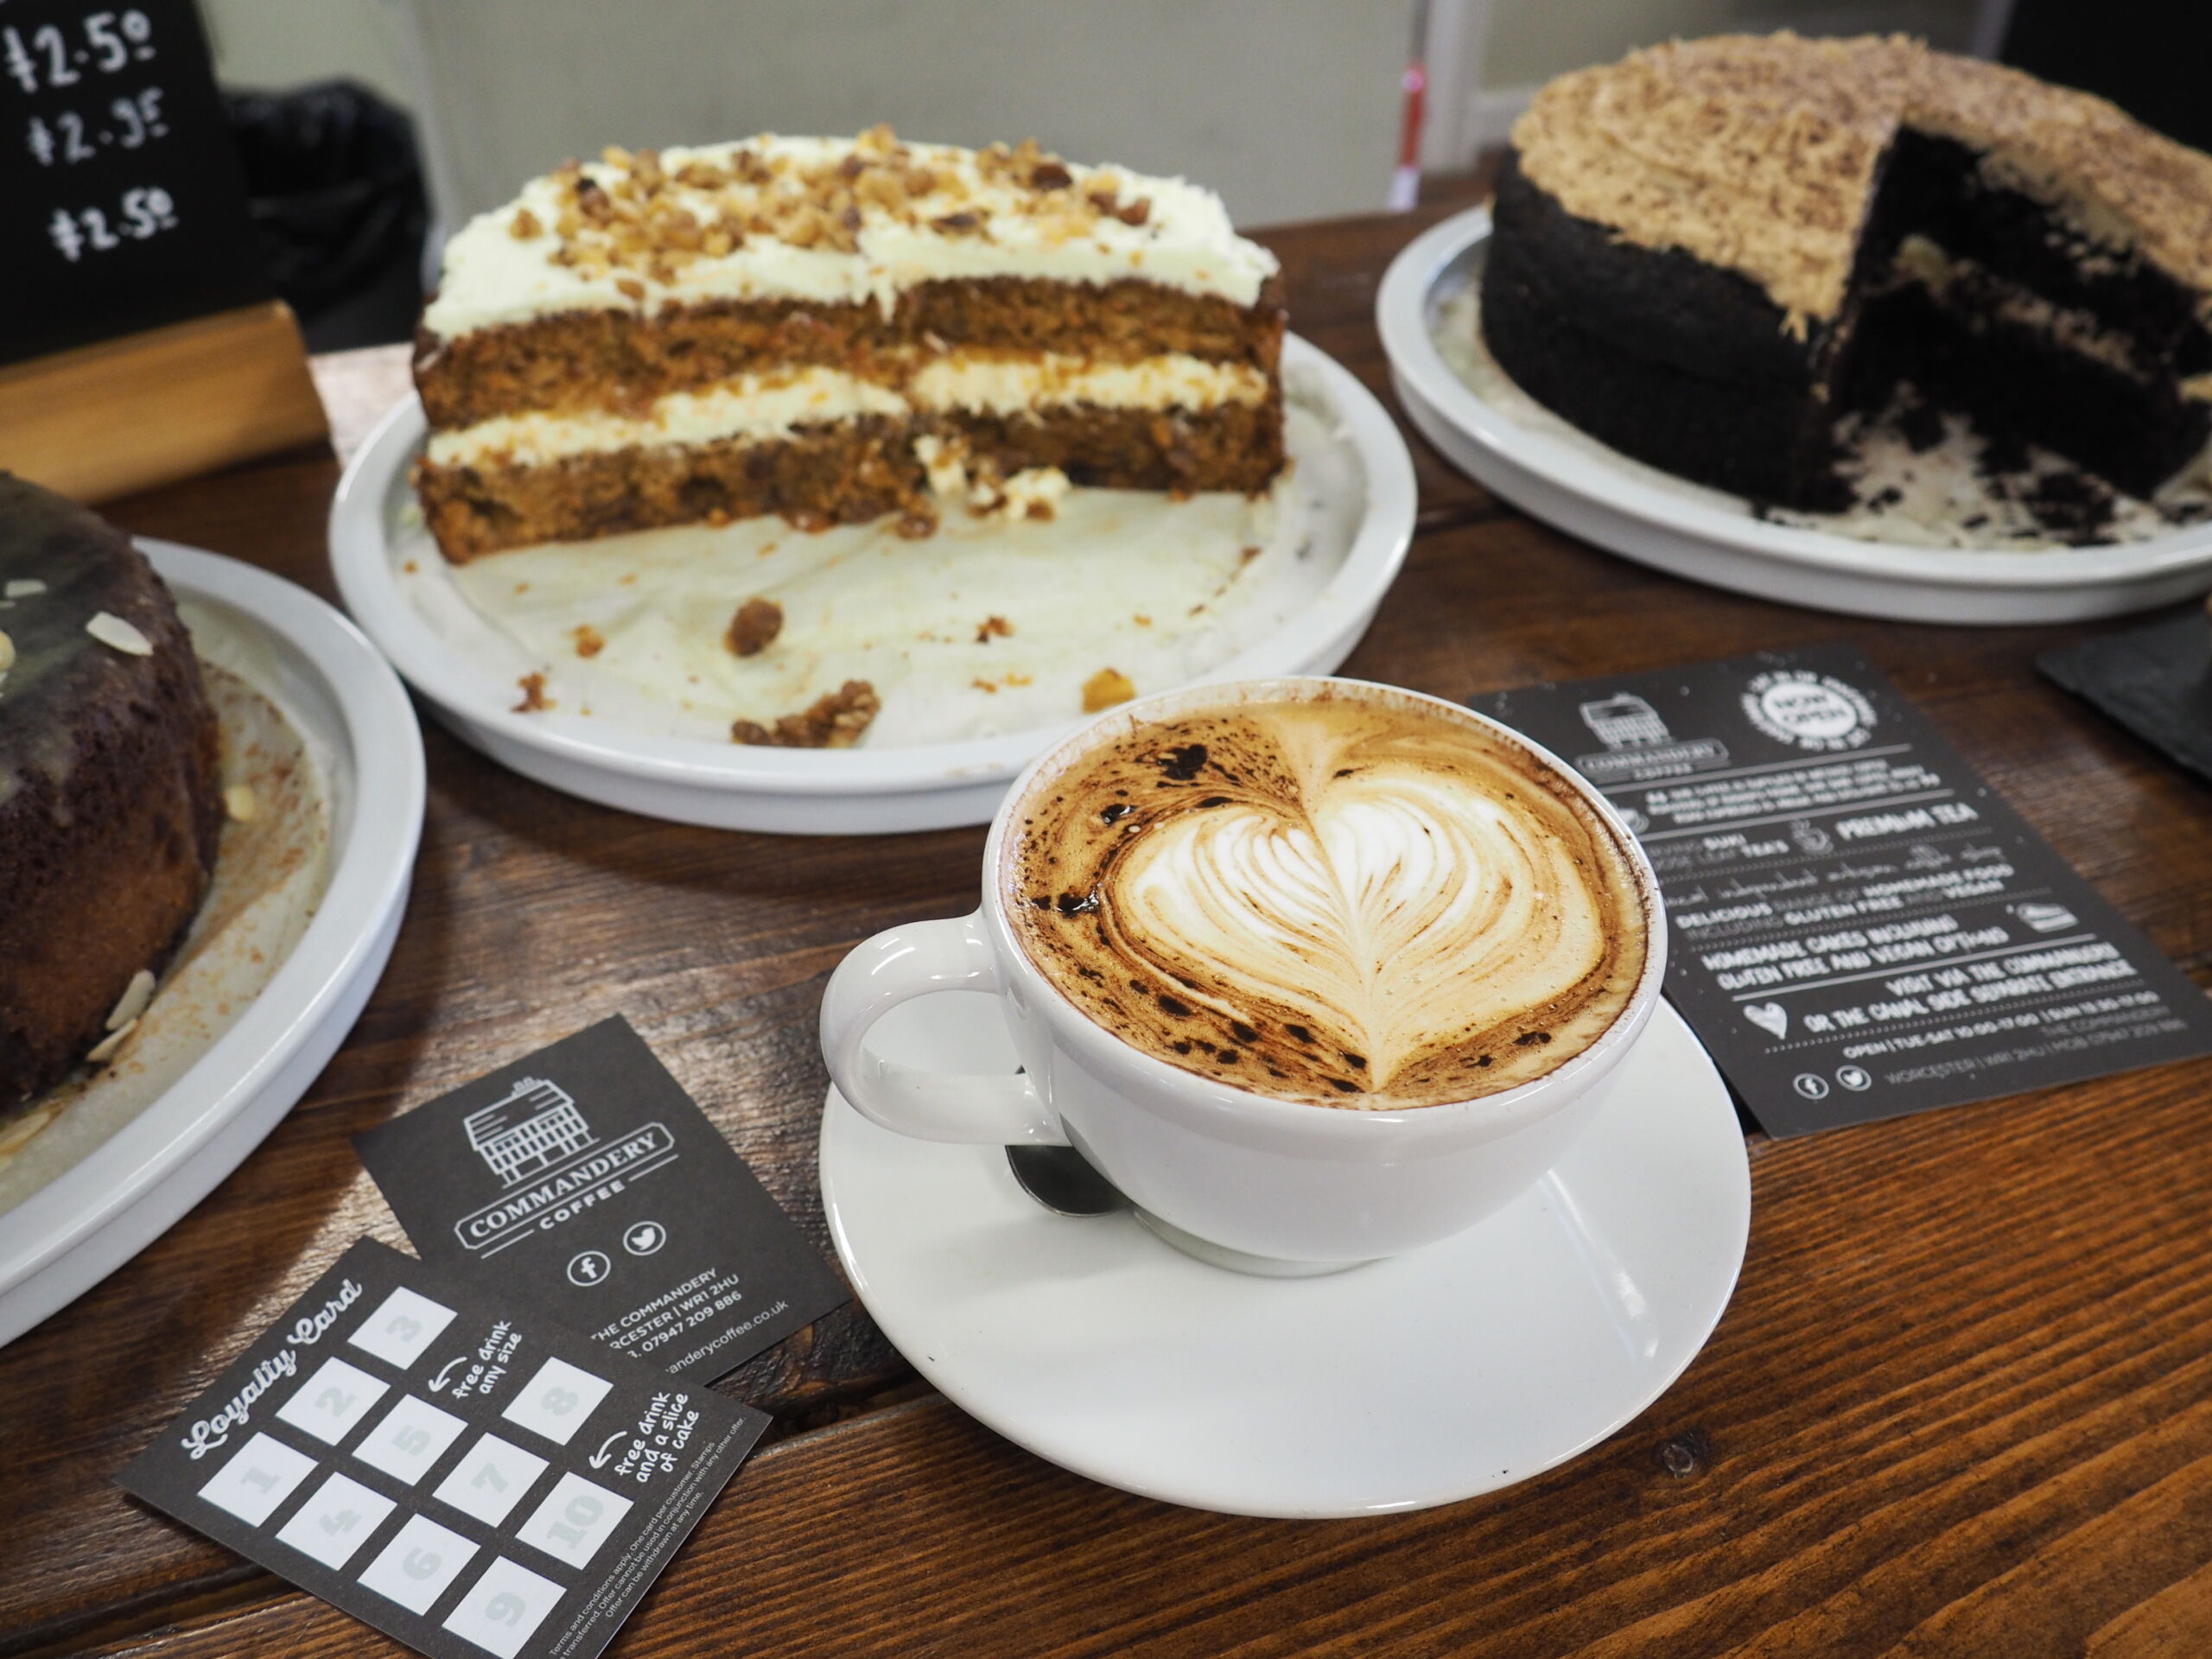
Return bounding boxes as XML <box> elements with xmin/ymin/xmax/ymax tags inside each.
<box><xmin>1000</xmin><ymin>690</ymin><xmax>1646</xmax><ymax>1109</ymax></box>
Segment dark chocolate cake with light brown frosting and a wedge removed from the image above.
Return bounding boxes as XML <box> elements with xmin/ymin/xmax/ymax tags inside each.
<box><xmin>1482</xmin><ymin>33</ymin><xmax>2212</xmax><ymax>511</ymax></box>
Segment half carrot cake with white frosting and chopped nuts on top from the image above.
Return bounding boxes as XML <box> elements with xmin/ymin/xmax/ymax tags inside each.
<box><xmin>416</xmin><ymin>128</ymin><xmax>1283</xmax><ymax>562</ymax></box>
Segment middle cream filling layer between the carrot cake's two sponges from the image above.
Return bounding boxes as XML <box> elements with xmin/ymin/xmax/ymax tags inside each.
<box><xmin>425</xmin><ymin>352</ymin><xmax>1269</xmax><ymax>467</ymax></box>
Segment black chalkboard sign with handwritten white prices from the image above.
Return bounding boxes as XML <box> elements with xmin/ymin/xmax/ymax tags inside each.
<box><xmin>0</xmin><ymin>0</ymin><xmax>270</xmax><ymax>363</ymax></box>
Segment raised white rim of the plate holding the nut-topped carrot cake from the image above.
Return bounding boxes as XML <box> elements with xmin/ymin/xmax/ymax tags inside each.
<box><xmin>329</xmin><ymin>336</ymin><xmax>1415</xmax><ymax>834</ymax></box>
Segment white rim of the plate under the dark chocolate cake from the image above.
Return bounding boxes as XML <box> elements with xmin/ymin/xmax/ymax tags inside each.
<box><xmin>1376</xmin><ymin>208</ymin><xmax>2212</xmax><ymax>624</ymax></box>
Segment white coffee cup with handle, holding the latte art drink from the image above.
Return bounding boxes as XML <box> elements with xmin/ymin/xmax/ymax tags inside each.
<box><xmin>821</xmin><ymin>679</ymin><xmax>1666</xmax><ymax>1274</ymax></box>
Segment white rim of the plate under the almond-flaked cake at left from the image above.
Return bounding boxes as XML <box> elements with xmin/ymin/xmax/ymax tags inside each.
<box><xmin>0</xmin><ymin>540</ymin><xmax>423</xmax><ymax>1343</ymax></box>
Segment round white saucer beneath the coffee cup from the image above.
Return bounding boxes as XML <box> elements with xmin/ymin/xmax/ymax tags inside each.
<box><xmin>821</xmin><ymin>993</ymin><xmax>1752</xmax><ymax>1517</ymax></box>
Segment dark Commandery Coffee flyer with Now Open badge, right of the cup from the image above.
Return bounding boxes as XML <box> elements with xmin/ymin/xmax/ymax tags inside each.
<box><xmin>1473</xmin><ymin>646</ymin><xmax>2212</xmax><ymax>1135</ymax></box>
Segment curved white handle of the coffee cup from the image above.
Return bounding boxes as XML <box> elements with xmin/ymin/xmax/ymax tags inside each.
<box><xmin>823</xmin><ymin>912</ymin><xmax>1068</xmax><ymax>1146</ymax></box>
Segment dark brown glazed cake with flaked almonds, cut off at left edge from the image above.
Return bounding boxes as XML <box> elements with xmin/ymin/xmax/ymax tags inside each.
<box><xmin>0</xmin><ymin>474</ymin><xmax>224</xmax><ymax>1113</ymax></box>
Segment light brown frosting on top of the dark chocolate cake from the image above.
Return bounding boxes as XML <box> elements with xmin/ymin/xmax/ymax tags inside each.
<box><xmin>1513</xmin><ymin>33</ymin><xmax>2212</xmax><ymax>327</ymax></box>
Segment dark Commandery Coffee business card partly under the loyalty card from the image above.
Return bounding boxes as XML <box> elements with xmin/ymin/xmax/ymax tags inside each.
<box><xmin>354</xmin><ymin>1018</ymin><xmax>847</xmax><ymax>1382</ymax></box>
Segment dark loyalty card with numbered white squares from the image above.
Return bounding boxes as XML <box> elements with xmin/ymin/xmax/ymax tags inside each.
<box><xmin>118</xmin><ymin>1239</ymin><xmax>767</xmax><ymax>1659</ymax></box>
